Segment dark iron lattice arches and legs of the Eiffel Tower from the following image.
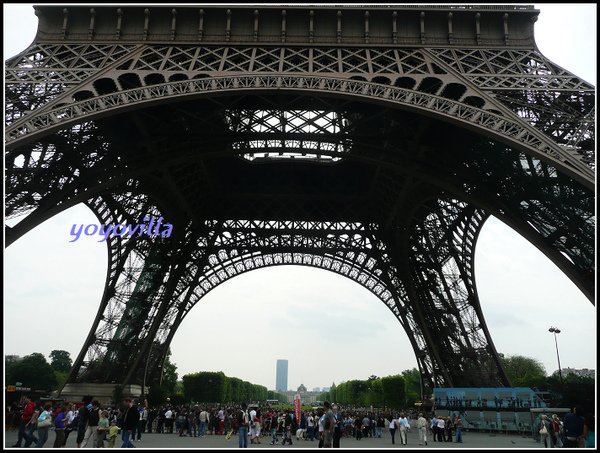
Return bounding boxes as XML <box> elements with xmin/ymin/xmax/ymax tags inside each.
<box><xmin>5</xmin><ymin>5</ymin><xmax>595</xmax><ymax>387</ymax></box>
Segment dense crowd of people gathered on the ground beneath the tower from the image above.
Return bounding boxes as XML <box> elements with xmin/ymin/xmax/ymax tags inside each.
<box><xmin>6</xmin><ymin>397</ymin><xmax>595</xmax><ymax>448</ymax></box>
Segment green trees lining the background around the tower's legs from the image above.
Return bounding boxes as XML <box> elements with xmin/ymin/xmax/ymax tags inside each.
<box><xmin>4</xmin><ymin>350</ymin><xmax>596</xmax><ymax>410</ymax></box>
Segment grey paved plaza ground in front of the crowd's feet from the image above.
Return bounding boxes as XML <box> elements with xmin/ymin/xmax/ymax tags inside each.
<box><xmin>4</xmin><ymin>430</ymin><xmax>541</xmax><ymax>449</ymax></box>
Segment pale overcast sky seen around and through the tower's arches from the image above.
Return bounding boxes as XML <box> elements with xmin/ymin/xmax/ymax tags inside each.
<box><xmin>4</xmin><ymin>4</ymin><xmax>597</xmax><ymax>390</ymax></box>
